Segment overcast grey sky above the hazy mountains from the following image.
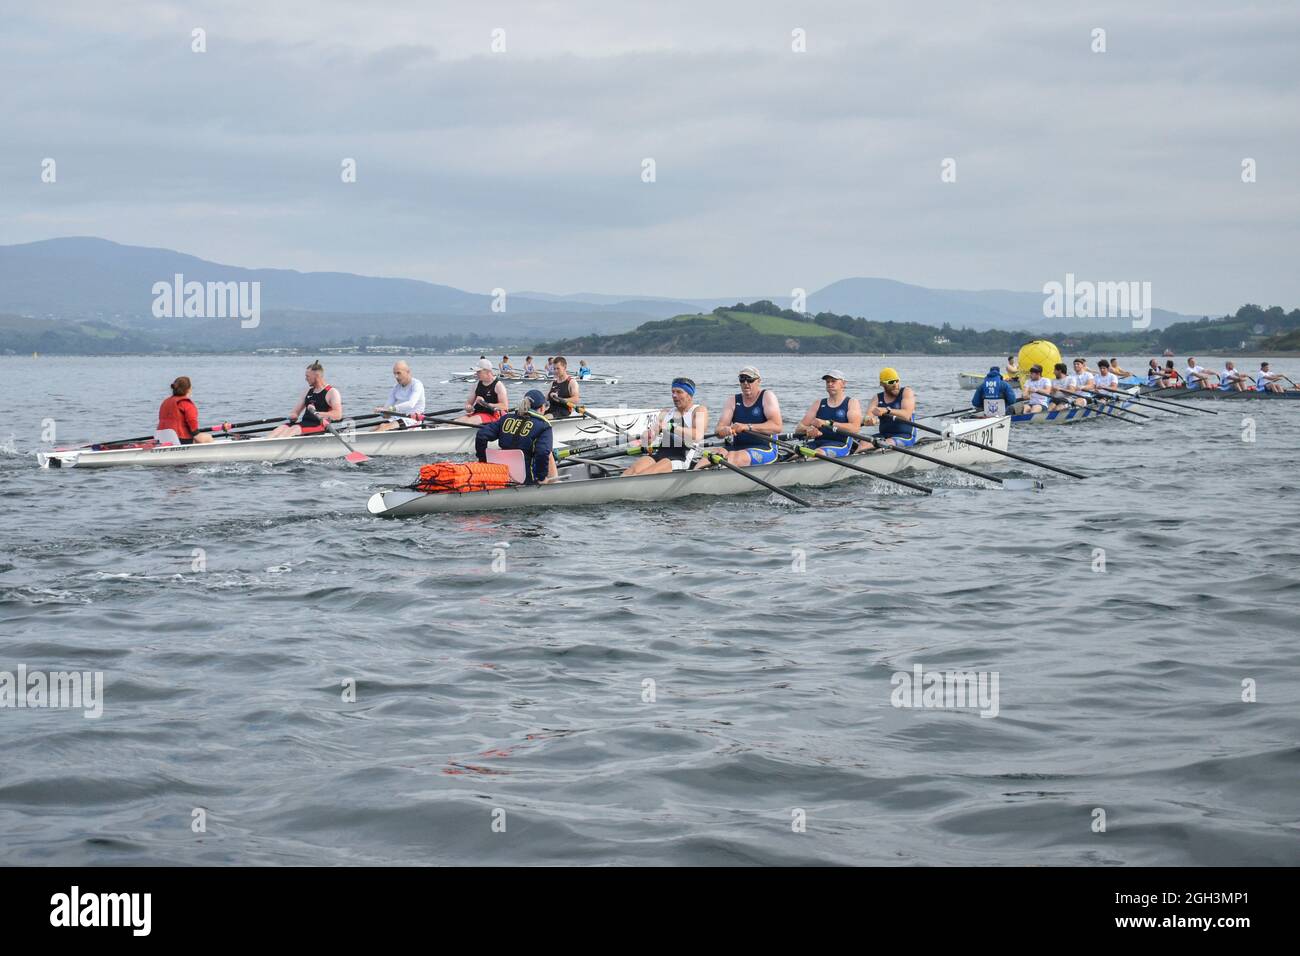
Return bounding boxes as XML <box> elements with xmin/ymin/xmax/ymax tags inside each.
<box><xmin>0</xmin><ymin>0</ymin><xmax>1300</xmax><ymax>313</ymax></box>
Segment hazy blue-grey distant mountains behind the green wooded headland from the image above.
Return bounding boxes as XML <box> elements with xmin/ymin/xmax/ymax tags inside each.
<box><xmin>0</xmin><ymin>237</ymin><xmax>1200</xmax><ymax>351</ymax></box>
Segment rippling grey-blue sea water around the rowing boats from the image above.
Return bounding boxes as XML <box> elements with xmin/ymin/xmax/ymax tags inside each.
<box><xmin>0</xmin><ymin>356</ymin><xmax>1300</xmax><ymax>865</ymax></box>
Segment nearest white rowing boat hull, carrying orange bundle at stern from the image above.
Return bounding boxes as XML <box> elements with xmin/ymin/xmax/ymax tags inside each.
<box><xmin>367</xmin><ymin>416</ymin><xmax>1011</xmax><ymax>518</ymax></box>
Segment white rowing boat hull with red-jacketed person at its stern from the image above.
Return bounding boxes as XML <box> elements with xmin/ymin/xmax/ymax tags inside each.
<box><xmin>36</xmin><ymin>408</ymin><xmax>658</xmax><ymax>468</ymax></box>
